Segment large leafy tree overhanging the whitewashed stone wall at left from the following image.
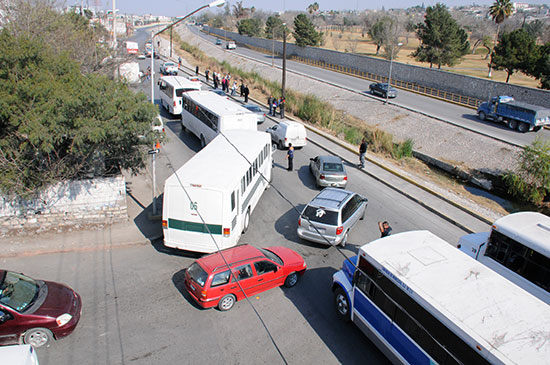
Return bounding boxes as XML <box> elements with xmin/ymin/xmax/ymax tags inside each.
<box><xmin>0</xmin><ymin>0</ymin><xmax>157</xmax><ymax>198</ymax></box>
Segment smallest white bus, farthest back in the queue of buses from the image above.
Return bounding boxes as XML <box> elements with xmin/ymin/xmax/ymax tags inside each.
<box><xmin>158</xmin><ymin>76</ymin><xmax>201</xmax><ymax>115</ymax></box>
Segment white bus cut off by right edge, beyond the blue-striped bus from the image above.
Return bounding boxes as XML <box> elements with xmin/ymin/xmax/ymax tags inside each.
<box><xmin>458</xmin><ymin>212</ymin><xmax>550</xmax><ymax>304</ymax></box>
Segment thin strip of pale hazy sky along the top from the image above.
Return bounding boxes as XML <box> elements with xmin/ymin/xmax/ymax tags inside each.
<box><xmin>100</xmin><ymin>0</ymin><xmax>548</xmax><ymax>16</ymax></box>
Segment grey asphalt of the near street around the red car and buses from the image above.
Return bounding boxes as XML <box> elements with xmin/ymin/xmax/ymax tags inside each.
<box><xmin>8</xmin><ymin>32</ymin><xmax>480</xmax><ymax>365</ymax></box>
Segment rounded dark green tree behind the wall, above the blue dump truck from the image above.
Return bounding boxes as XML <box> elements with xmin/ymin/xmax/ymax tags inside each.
<box><xmin>491</xmin><ymin>29</ymin><xmax>538</xmax><ymax>82</ymax></box>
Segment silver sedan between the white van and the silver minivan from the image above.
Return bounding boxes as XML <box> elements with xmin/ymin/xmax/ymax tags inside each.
<box><xmin>309</xmin><ymin>156</ymin><xmax>348</xmax><ymax>188</ymax></box>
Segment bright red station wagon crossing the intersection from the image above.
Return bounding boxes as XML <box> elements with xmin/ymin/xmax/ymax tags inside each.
<box><xmin>185</xmin><ymin>245</ymin><xmax>306</xmax><ymax>311</ymax></box>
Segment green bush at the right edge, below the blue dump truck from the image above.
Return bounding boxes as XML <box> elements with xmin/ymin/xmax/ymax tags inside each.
<box><xmin>504</xmin><ymin>139</ymin><xmax>550</xmax><ymax>204</ymax></box>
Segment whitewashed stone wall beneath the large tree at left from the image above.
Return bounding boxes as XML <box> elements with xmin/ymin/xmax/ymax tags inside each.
<box><xmin>0</xmin><ymin>176</ymin><xmax>128</xmax><ymax>236</ymax></box>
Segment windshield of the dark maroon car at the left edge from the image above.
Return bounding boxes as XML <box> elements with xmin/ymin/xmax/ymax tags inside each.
<box><xmin>0</xmin><ymin>271</ymin><xmax>40</xmax><ymax>312</ymax></box>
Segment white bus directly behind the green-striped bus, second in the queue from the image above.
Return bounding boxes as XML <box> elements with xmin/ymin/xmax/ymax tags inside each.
<box><xmin>181</xmin><ymin>91</ymin><xmax>258</xmax><ymax>147</ymax></box>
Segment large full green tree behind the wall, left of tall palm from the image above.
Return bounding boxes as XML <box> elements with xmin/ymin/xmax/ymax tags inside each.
<box><xmin>413</xmin><ymin>3</ymin><xmax>470</xmax><ymax>68</ymax></box>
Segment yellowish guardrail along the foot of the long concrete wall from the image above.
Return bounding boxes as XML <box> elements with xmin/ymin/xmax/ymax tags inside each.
<box><xmin>294</xmin><ymin>55</ymin><xmax>484</xmax><ymax>109</ymax></box>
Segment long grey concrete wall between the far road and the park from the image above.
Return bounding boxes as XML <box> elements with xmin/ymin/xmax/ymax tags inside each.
<box><xmin>204</xmin><ymin>26</ymin><xmax>550</xmax><ymax>108</ymax></box>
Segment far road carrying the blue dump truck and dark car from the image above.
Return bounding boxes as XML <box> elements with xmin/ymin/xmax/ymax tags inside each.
<box><xmin>188</xmin><ymin>26</ymin><xmax>550</xmax><ymax>146</ymax></box>
